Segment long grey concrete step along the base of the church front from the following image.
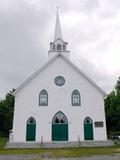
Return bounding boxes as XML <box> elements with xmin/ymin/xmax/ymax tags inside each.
<box><xmin>5</xmin><ymin>140</ymin><xmax>114</xmax><ymax>148</ymax></box>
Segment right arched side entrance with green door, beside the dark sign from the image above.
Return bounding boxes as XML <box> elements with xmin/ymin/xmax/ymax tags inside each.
<box><xmin>84</xmin><ymin>117</ymin><xmax>93</xmax><ymax>140</ymax></box>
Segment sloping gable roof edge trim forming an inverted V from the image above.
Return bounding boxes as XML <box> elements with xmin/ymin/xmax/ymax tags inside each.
<box><xmin>13</xmin><ymin>52</ymin><xmax>106</xmax><ymax>96</ymax></box>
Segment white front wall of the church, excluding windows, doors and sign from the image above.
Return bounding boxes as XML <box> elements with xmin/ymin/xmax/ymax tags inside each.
<box><xmin>13</xmin><ymin>56</ymin><xmax>107</xmax><ymax>142</ymax></box>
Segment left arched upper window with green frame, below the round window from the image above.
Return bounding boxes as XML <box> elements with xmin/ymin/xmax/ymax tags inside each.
<box><xmin>39</xmin><ymin>90</ymin><xmax>48</xmax><ymax>106</ymax></box>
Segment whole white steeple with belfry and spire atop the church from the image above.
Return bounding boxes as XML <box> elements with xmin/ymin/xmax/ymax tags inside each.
<box><xmin>48</xmin><ymin>9</ymin><xmax>69</xmax><ymax>58</ymax></box>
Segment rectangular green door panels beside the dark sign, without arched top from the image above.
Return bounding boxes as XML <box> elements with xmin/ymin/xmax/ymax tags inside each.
<box><xmin>84</xmin><ymin>121</ymin><xmax>93</xmax><ymax>140</ymax></box>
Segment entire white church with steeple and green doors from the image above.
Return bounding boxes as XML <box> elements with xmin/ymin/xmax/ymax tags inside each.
<box><xmin>10</xmin><ymin>12</ymin><xmax>107</xmax><ymax>143</ymax></box>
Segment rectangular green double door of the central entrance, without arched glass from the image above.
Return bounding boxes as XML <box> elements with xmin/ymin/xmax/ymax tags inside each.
<box><xmin>52</xmin><ymin>124</ymin><xmax>68</xmax><ymax>141</ymax></box>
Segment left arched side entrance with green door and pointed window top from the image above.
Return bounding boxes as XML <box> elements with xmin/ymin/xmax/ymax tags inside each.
<box><xmin>26</xmin><ymin>117</ymin><xmax>36</xmax><ymax>141</ymax></box>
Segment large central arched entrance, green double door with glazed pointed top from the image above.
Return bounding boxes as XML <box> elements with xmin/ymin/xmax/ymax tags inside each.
<box><xmin>52</xmin><ymin>111</ymin><xmax>68</xmax><ymax>141</ymax></box>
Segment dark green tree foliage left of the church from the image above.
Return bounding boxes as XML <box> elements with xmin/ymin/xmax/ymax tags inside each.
<box><xmin>0</xmin><ymin>89</ymin><xmax>14</xmax><ymax>136</ymax></box>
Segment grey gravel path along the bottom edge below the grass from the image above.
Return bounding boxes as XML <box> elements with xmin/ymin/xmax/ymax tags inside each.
<box><xmin>0</xmin><ymin>154</ymin><xmax>120</xmax><ymax>160</ymax></box>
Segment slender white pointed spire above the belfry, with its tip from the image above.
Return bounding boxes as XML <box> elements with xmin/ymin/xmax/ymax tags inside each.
<box><xmin>54</xmin><ymin>6</ymin><xmax>63</xmax><ymax>40</ymax></box>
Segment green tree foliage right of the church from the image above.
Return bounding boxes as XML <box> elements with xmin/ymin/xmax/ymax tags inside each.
<box><xmin>105</xmin><ymin>77</ymin><xmax>120</xmax><ymax>134</ymax></box>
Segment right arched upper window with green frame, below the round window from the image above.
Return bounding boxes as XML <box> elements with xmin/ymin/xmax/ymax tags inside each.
<box><xmin>72</xmin><ymin>89</ymin><xmax>81</xmax><ymax>106</ymax></box>
